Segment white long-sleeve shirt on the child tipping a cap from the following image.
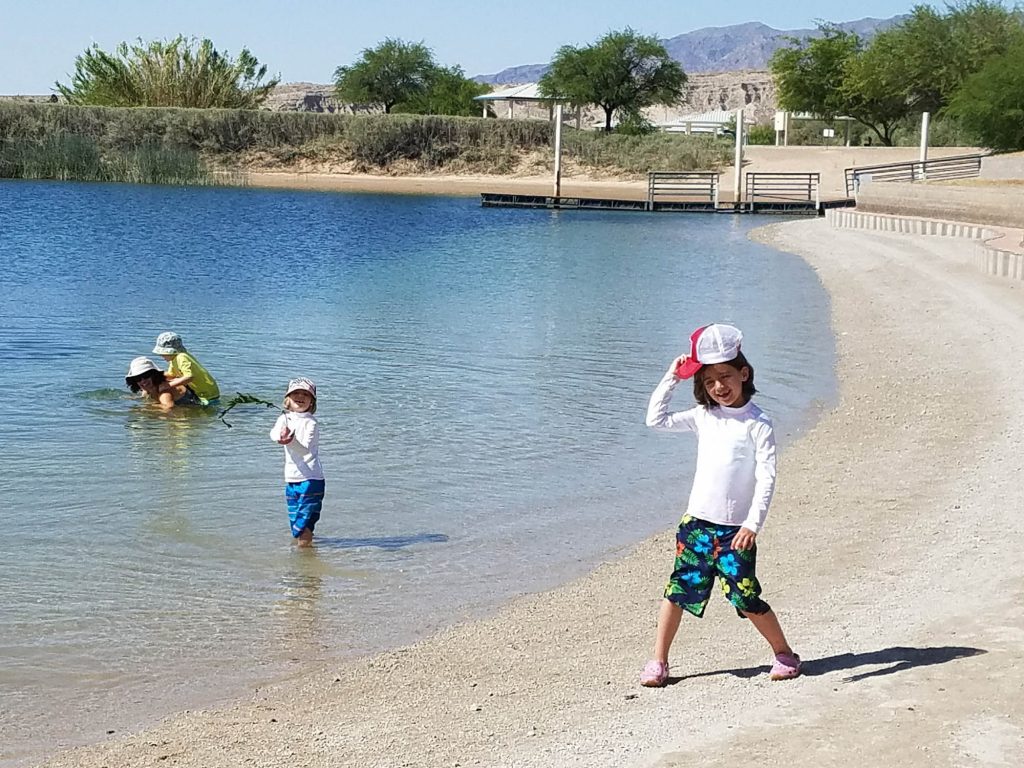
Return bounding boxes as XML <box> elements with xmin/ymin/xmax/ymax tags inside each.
<box><xmin>647</xmin><ymin>372</ymin><xmax>775</xmax><ymax>534</ymax></box>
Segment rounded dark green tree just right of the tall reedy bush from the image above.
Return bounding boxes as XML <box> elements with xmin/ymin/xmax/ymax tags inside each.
<box><xmin>334</xmin><ymin>38</ymin><xmax>437</xmax><ymax>114</ymax></box>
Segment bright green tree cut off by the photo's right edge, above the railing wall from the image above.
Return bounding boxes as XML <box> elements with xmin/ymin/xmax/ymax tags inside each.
<box><xmin>946</xmin><ymin>40</ymin><xmax>1024</xmax><ymax>151</ymax></box>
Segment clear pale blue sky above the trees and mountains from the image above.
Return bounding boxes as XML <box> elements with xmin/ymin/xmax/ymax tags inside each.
<box><xmin>0</xmin><ymin>0</ymin><xmax>921</xmax><ymax>94</ymax></box>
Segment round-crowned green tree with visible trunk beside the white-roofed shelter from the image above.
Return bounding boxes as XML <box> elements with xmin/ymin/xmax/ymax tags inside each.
<box><xmin>540</xmin><ymin>29</ymin><xmax>686</xmax><ymax>131</ymax></box>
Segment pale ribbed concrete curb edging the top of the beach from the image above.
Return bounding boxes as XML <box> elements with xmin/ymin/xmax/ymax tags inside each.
<box><xmin>825</xmin><ymin>208</ymin><xmax>1024</xmax><ymax>281</ymax></box>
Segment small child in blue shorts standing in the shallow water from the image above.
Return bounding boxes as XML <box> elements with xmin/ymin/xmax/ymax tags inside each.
<box><xmin>270</xmin><ymin>378</ymin><xmax>324</xmax><ymax>547</ymax></box>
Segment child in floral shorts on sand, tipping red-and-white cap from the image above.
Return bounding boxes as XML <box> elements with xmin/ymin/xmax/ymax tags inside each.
<box><xmin>640</xmin><ymin>324</ymin><xmax>800</xmax><ymax>687</ymax></box>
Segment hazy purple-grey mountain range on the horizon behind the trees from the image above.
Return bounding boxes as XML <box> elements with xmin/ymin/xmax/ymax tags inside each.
<box><xmin>474</xmin><ymin>15</ymin><xmax>906</xmax><ymax>85</ymax></box>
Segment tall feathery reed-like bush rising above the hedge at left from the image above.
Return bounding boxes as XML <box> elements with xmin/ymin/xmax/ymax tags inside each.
<box><xmin>56</xmin><ymin>35</ymin><xmax>280</xmax><ymax>110</ymax></box>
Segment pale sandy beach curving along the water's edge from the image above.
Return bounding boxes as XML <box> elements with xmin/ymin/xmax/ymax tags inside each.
<box><xmin>25</xmin><ymin>219</ymin><xmax>1024</xmax><ymax>768</ymax></box>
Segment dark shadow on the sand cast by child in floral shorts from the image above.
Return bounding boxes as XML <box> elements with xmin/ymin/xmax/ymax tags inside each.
<box><xmin>666</xmin><ymin>645</ymin><xmax>988</xmax><ymax>685</ymax></box>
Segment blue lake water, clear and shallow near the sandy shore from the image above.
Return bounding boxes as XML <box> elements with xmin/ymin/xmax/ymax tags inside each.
<box><xmin>0</xmin><ymin>182</ymin><xmax>835</xmax><ymax>761</ymax></box>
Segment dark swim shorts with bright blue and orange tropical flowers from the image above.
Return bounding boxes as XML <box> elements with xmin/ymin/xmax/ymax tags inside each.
<box><xmin>665</xmin><ymin>515</ymin><xmax>771</xmax><ymax>618</ymax></box>
